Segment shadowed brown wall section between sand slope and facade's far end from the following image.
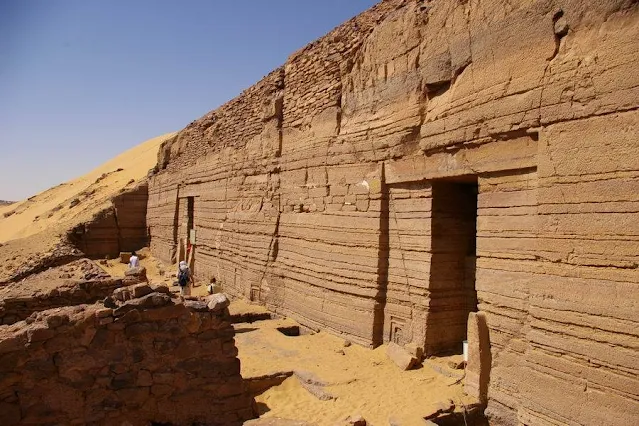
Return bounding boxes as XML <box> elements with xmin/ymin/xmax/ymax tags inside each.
<box><xmin>68</xmin><ymin>182</ymin><xmax>149</xmax><ymax>259</ymax></box>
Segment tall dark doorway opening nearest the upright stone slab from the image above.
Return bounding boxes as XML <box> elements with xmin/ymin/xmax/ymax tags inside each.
<box><xmin>425</xmin><ymin>176</ymin><xmax>478</xmax><ymax>353</ymax></box>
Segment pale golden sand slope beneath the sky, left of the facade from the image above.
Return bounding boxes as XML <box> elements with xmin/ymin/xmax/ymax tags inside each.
<box><xmin>0</xmin><ymin>134</ymin><xmax>174</xmax><ymax>283</ymax></box>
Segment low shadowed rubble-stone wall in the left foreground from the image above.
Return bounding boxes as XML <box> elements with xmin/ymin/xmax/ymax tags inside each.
<box><xmin>0</xmin><ymin>285</ymin><xmax>254</xmax><ymax>426</ymax></box>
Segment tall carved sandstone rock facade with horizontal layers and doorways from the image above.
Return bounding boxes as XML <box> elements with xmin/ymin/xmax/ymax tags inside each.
<box><xmin>148</xmin><ymin>0</ymin><xmax>639</xmax><ymax>425</ymax></box>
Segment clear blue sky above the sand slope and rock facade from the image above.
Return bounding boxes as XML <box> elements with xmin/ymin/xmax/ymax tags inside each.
<box><xmin>0</xmin><ymin>0</ymin><xmax>377</xmax><ymax>200</ymax></box>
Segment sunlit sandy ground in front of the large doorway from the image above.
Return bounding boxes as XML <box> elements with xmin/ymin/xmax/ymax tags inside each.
<box><xmin>230</xmin><ymin>301</ymin><xmax>472</xmax><ymax>426</ymax></box>
